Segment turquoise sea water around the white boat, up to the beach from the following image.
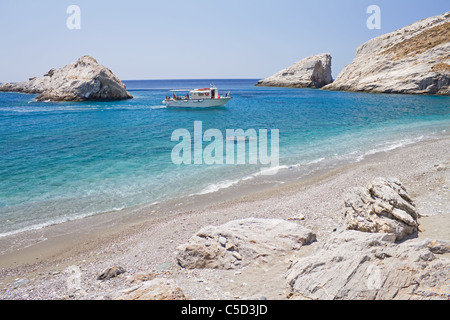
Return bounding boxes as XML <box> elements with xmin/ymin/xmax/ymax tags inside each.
<box><xmin>0</xmin><ymin>79</ymin><xmax>450</xmax><ymax>235</ymax></box>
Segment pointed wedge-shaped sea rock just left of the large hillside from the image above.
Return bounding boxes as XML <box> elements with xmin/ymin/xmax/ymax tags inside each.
<box><xmin>256</xmin><ymin>53</ymin><xmax>333</xmax><ymax>88</ymax></box>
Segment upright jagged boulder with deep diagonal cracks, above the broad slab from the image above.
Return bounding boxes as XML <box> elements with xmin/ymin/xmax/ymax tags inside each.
<box><xmin>343</xmin><ymin>178</ymin><xmax>419</xmax><ymax>240</ymax></box>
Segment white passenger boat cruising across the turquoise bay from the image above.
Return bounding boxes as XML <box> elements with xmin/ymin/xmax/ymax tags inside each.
<box><xmin>162</xmin><ymin>86</ymin><xmax>231</xmax><ymax>108</ymax></box>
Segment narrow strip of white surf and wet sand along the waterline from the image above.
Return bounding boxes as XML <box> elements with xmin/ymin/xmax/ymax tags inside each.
<box><xmin>0</xmin><ymin>131</ymin><xmax>442</xmax><ymax>242</ymax></box>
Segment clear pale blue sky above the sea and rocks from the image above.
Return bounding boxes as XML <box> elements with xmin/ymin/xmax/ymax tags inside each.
<box><xmin>0</xmin><ymin>0</ymin><xmax>450</xmax><ymax>82</ymax></box>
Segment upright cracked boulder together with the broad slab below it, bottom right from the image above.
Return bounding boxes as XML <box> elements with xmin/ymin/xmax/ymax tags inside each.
<box><xmin>286</xmin><ymin>178</ymin><xmax>450</xmax><ymax>300</ymax></box>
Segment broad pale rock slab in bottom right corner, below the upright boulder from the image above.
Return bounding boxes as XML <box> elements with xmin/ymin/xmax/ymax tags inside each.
<box><xmin>286</xmin><ymin>230</ymin><xmax>450</xmax><ymax>300</ymax></box>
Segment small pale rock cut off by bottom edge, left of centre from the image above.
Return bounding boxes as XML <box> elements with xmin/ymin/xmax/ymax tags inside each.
<box><xmin>114</xmin><ymin>278</ymin><xmax>187</xmax><ymax>300</ymax></box>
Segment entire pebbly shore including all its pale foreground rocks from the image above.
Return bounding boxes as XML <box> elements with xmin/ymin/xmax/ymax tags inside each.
<box><xmin>0</xmin><ymin>136</ymin><xmax>450</xmax><ymax>300</ymax></box>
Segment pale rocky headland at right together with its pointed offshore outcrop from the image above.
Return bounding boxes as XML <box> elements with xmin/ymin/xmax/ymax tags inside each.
<box><xmin>256</xmin><ymin>12</ymin><xmax>450</xmax><ymax>95</ymax></box>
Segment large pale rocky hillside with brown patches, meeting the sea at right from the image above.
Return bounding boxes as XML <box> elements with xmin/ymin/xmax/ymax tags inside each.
<box><xmin>323</xmin><ymin>12</ymin><xmax>450</xmax><ymax>95</ymax></box>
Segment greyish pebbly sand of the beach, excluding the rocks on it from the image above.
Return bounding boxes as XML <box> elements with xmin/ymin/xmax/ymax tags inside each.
<box><xmin>0</xmin><ymin>134</ymin><xmax>450</xmax><ymax>299</ymax></box>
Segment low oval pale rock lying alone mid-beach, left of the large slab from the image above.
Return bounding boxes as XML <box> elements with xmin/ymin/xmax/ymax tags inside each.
<box><xmin>177</xmin><ymin>218</ymin><xmax>316</xmax><ymax>269</ymax></box>
